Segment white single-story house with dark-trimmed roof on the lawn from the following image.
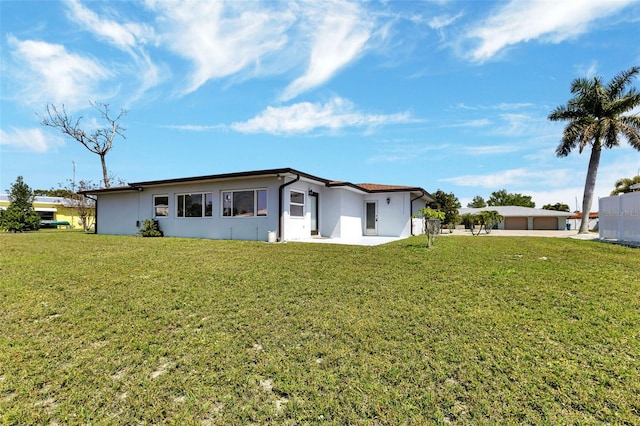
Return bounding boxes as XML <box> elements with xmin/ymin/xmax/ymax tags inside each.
<box><xmin>84</xmin><ymin>168</ymin><xmax>434</xmax><ymax>241</ymax></box>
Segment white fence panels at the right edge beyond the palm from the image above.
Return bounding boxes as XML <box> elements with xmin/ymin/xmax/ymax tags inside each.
<box><xmin>599</xmin><ymin>192</ymin><xmax>640</xmax><ymax>242</ymax></box>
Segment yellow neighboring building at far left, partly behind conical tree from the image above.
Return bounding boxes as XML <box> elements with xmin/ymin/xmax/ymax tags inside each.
<box><xmin>0</xmin><ymin>194</ymin><xmax>94</xmax><ymax>228</ymax></box>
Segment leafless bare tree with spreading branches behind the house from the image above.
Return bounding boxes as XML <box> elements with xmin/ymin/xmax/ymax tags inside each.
<box><xmin>38</xmin><ymin>102</ymin><xmax>127</xmax><ymax>188</ymax></box>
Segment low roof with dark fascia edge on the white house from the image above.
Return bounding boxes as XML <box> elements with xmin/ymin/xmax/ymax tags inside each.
<box><xmin>82</xmin><ymin>168</ymin><xmax>434</xmax><ymax>201</ymax></box>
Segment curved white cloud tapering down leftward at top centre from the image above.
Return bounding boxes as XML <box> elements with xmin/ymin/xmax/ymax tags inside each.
<box><xmin>281</xmin><ymin>2</ymin><xmax>373</xmax><ymax>101</ymax></box>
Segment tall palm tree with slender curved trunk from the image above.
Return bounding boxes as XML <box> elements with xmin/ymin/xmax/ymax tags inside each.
<box><xmin>548</xmin><ymin>67</ymin><xmax>640</xmax><ymax>234</ymax></box>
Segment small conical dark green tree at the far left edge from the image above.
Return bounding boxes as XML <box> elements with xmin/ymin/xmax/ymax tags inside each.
<box><xmin>0</xmin><ymin>176</ymin><xmax>40</xmax><ymax>232</ymax></box>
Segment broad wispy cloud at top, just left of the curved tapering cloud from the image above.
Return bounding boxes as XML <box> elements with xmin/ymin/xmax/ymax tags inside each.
<box><xmin>147</xmin><ymin>0</ymin><xmax>295</xmax><ymax>93</ymax></box>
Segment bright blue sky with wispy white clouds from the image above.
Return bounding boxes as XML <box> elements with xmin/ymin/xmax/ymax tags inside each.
<box><xmin>0</xmin><ymin>0</ymin><xmax>640</xmax><ymax>210</ymax></box>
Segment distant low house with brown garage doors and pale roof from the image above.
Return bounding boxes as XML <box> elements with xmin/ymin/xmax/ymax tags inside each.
<box><xmin>458</xmin><ymin>206</ymin><xmax>573</xmax><ymax>230</ymax></box>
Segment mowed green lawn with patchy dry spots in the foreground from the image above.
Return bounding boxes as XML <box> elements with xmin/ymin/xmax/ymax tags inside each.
<box><xmin>0</xmin><ymin>231</ymin><xmax>640</xmax><ymax>425</ymax></box>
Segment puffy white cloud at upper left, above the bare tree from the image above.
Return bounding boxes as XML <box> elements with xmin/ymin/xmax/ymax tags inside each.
<box><xmin>7</xmin><ymin>35</ymin><xmax>112</xmax><ymax>107</ymax></box>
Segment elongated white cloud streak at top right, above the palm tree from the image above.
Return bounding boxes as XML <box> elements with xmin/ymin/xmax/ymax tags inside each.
<box><xmin>463</xmin><ymin>0</ymin><xmax>633</xmax><ymax>62</ymax></box>
